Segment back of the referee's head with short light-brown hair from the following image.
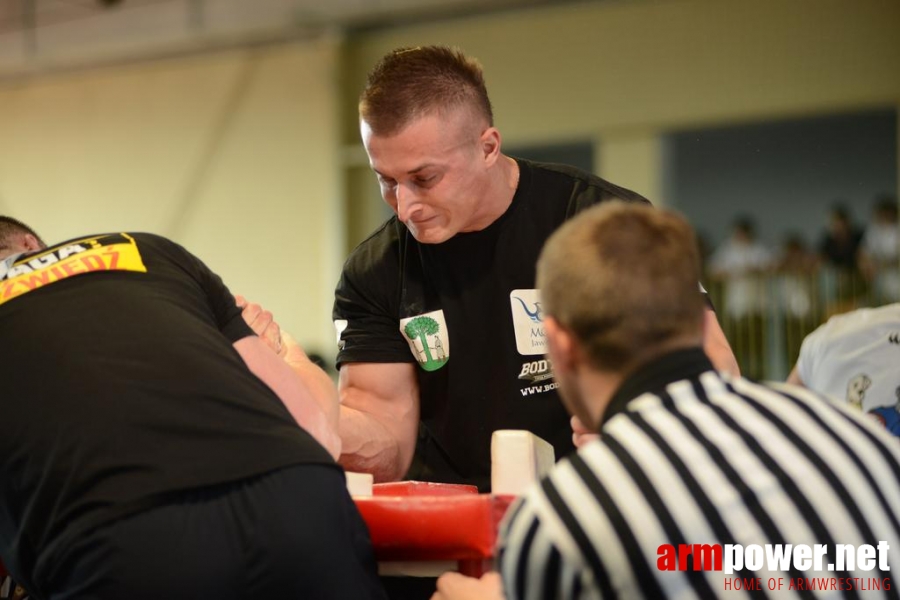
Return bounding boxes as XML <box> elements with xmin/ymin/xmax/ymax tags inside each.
<box><xmin>537</xmin><ymin>201</ymin><xmax>704</xmax><ymax>371</ymax></box>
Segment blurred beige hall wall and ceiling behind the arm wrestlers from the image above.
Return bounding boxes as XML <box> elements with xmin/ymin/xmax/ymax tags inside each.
<box><xmin>0</xmin><ymin>0</ymin><xmax>900</xmax><ymax>370</ymax></box>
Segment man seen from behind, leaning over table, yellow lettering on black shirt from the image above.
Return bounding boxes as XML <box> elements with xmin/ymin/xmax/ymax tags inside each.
<box><xmin>0</xmin><ymin>217</ymin><xmax>383</xmax><ymax>600</ymax></box>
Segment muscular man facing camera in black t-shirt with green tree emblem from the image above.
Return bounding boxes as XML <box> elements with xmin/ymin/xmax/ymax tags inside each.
<box><xmin>334</xmin><ymin>47</ymin><xmax>737</xmax><ymax>489</ymax></box>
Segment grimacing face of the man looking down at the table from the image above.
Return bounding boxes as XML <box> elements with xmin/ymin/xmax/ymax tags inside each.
<box><xmin>360</xmin><ymin>111</ymin><xmax>490</xmax><ymax>244</ymax></box>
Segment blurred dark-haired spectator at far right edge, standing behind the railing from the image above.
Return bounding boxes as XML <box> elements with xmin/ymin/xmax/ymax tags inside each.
<box><xmin>859</xmin><ymin>195</ymin><xmax>900</xmax><ymax>304</ymax></box>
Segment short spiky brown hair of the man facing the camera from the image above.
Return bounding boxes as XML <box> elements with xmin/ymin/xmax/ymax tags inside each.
<box><xmin>359</xmin><ymin>46</ymin><xmax>494</xmax><ymax>136</ymax></box>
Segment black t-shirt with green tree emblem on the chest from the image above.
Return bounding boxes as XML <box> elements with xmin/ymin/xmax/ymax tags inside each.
<box><xmin>334</xmin><ymin>160</ymin><xmax>647</xmax><ymax>490</ymax></box>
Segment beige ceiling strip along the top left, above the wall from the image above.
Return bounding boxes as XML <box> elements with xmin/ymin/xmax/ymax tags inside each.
<box><xmin>0</xmin><ymin>0</ymin><xmax>584</xmax><ymax>75</ymax></box>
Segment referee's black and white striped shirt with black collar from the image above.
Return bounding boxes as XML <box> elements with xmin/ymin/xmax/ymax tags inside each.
<box><xmin>499</xmin><ymin>349</ymin><xmax>900</xmax><ymax>599</ymax></box>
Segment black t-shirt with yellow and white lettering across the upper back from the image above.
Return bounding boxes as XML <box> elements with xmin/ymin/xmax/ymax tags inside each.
<box><xmin>0</xmin><ymin>233</ymin><xmax>337</xmax><ymax>587</ymax></box>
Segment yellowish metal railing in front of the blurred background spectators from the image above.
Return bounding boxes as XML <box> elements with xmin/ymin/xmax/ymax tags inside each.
<box><xmin>704</xmin><ymin>268</ymin><xmax>900</xmax><ymax>381</ymax></box>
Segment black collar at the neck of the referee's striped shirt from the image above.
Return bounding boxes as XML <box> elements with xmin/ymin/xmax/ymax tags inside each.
<box><xmin>600</xmin><ymin>347</ymin><xmax>713</xmax><ymax>428</ymax></box>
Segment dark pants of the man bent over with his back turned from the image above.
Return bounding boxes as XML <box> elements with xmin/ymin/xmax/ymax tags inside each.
<box><xmin>47</xmin><ymin>465</ymin><xmax>385</xmax><ymax>600</ymax></box>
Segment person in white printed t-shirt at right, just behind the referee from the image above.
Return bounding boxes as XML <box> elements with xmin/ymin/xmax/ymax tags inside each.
<box><xmin>788</xmin><ymin>303</ymin><xmax>900</xmax><ymax>435</ymax></box>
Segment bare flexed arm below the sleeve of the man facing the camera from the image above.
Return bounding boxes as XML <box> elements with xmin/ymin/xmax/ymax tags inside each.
<box><xmin>338</xmin><ymin>363</ymin><xmax>419</xmax><ymax>482</ymax></box>
